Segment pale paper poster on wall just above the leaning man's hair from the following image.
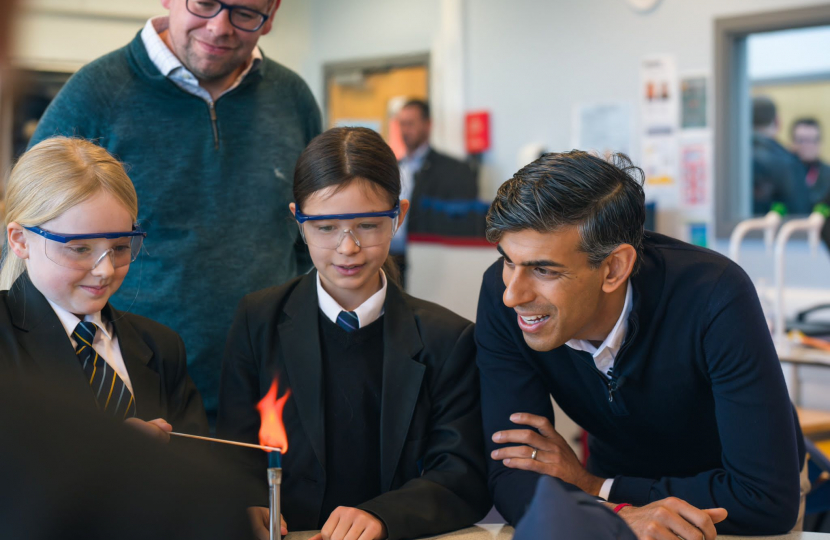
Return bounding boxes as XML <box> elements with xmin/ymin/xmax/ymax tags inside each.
<box><xmin>571</xmin><ymin>102</ymin><xmax>632</xmax><ymax>156</ymax></box>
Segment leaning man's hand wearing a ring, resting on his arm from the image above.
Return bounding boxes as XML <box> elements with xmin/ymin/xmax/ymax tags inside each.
<box><xmin>490</xmin><ymin>413</ymin><xmax>605</xmax><ymax>495</ymax></box>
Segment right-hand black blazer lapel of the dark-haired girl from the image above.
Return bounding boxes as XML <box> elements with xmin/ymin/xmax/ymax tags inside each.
<box><xmin>380</xmin><ymin>282</ymin><xmax>426</xmax><ymax>492</ymax></box>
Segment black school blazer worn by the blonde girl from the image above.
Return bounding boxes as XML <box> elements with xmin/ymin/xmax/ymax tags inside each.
<box><xmin>0</xmin><ymin>273</ymin><xmax>208</xmax><ymax>434</ymax></box>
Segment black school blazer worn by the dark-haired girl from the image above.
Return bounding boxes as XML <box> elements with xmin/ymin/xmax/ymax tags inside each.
<box><xmin>218</xmin><ymin>271</ymin><xmax>491</xmax><ymax>540</ymax></box>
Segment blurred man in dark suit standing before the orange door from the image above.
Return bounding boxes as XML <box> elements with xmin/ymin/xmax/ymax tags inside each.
<box><xmin>390</xmin><ymin>99</ymin><xmax>478</xmax><ymax>280</ymax></box>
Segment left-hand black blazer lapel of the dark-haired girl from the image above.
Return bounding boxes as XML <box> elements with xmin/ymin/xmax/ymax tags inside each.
<box><xmin>278</xmin><ymin>272</ymin><xmax>326</xmax><ymax>470</ymax></box>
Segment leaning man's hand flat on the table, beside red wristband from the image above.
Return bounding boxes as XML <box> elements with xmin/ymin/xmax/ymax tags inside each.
<box><xmin>608</xmin><ymin>497</ymin><xmax>726</xmax><ymax>540</ymax></box>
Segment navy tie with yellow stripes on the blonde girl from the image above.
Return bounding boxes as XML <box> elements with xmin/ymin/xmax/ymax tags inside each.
<box><xmin>73</xmin><ymin>321</ymin><xmax>135</xmax><ymax>418</ymax></box>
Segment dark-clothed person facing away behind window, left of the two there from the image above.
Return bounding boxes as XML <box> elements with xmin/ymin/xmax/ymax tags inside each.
<box><xmin>752</xmin><ymin>96</ymin><xmax>812</xmax><ymax>215</ymax></box>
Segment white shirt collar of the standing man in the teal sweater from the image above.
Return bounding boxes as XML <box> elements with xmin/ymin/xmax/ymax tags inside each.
<box><xmin>141</xmin><ymin>16</ymin><xmax>262</xmax><ymax>103</ymax></box>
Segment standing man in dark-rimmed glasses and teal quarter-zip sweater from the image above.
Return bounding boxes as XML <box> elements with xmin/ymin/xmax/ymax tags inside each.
<box><xmin>30</xmin><ymin>0</ymin><xmax>321</xmax><ymax>422</ymax></box>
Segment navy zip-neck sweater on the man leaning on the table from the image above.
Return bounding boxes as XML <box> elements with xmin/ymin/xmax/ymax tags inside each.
<box><xmin>476</xmin><ymin>232</ymin><xmax>804</xmax><ymax>535</ymax></box>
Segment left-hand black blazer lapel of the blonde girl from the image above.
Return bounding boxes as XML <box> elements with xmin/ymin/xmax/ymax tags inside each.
<box><xmin>8</xmin><ymin>274</ymin><xmax>95</xmax><ymax>406</ymax></box>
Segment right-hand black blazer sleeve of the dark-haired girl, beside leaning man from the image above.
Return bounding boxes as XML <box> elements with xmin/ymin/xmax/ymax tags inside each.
<box><xmin>358</xmin><ymin>325</ymin><xmax>490</xmax><ymax>540</ymax></box>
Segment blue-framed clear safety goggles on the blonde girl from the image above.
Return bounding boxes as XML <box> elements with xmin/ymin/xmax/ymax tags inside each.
<box><xmin>24</xmin><ymin>227</ymin><xmax>147</xmax><ymax>271</ymax></box>
